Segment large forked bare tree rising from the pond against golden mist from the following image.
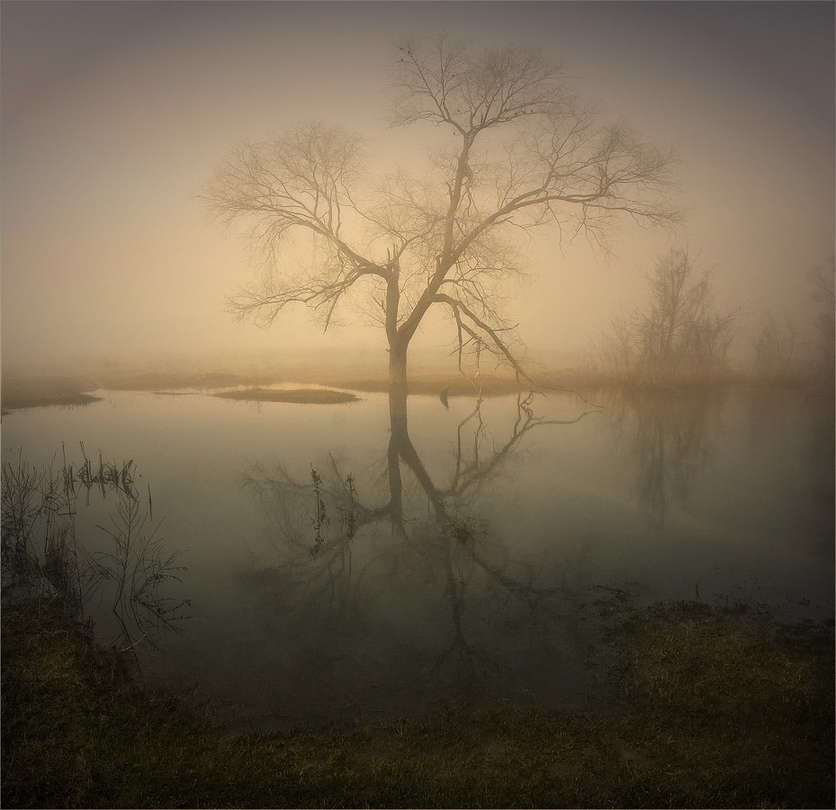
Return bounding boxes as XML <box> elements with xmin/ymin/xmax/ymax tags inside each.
<box><xmin>204</xmin><ymin>39</ymin><xmax>677</xmax><ymax>393</ymax></box>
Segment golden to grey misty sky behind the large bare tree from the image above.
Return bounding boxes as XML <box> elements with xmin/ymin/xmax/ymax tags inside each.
<box><xmin>0</xmin><ymin>0</ymin><xmax>834</xmax><ymax>370</ymax></box>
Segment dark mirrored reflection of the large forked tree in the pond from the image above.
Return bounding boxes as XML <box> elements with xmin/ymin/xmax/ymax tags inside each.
<box><xmin>238</xmin><ymin>392</ymin><xmax>588</xmax><ymax>706</ymax></box>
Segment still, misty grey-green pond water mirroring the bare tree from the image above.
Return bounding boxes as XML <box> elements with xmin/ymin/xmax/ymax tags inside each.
<box><xmin>3</xmin><ymin>391</ymin><xmax>834</xmax><ymax>726</ymax></box>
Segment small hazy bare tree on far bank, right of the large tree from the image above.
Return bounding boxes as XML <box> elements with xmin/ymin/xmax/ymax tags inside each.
<box><xmin>598</xmin><ymin>248</ymin><xmax>739</xmax><ymax>384</ymax></box>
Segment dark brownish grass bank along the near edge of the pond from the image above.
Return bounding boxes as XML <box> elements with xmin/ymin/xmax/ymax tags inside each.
<box><xmin>2</xmin><ymin>603</ymin><xmax>834</xmax><ymax>808</ymax></box>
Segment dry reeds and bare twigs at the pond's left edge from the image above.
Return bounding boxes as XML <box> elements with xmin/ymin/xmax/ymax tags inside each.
<box><xmin>0</xmin><ymin>443</ymin><xmax>190</xmax><ymax>651</ymax></box>
